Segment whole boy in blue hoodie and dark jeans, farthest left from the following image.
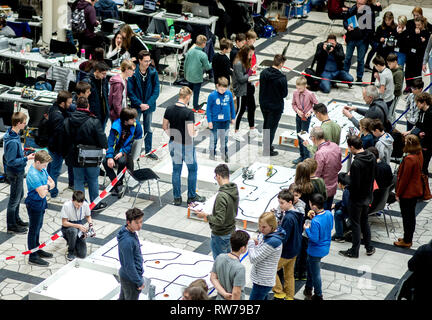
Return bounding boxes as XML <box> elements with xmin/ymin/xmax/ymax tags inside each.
<box><xmin>3</xmin><ymin>112</ymin><xmax>34</xmax><ymax>233</ymax></box>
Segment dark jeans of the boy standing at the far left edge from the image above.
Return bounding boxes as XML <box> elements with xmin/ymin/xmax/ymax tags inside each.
<box><xmin>6</xmin><ymin>170</ymin><xmax>24</xmax><ymax>228</ymax></box>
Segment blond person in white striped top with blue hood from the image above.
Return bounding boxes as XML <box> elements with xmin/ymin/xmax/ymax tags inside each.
<box><xmin>248</xmin><ymin>212</ymin><xmax>286</xmax><ymax>300</ymax></box>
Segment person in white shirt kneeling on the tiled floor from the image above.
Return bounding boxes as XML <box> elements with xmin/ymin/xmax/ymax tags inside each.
<box><xmin>60</xmin><ymin>190</ymin><xmax>95</xmax><ymax>261</ymax></box>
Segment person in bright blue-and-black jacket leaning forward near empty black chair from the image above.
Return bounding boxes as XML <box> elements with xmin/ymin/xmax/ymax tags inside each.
<box><xmin>103</xmin><ymin>108</ymin><xmax>142</xmax><ymax>197</ymax></box>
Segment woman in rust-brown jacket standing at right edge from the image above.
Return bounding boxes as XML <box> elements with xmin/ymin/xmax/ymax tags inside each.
<box><xmin>393</xmin><ymin>134</ymin><xmax>424</xmax><ymax>248</ymax></box>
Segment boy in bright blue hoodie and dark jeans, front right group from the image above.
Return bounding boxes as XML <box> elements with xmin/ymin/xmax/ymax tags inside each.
<box><xmin>303</xmin><ymin>193</ymin><xmax>333</xmax><ymax>300</ymax></box>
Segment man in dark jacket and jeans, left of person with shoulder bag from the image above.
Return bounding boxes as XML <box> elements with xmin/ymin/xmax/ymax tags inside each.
<box><xmin>46</xmin><ymin>91</ymin><xmax>72</xmax><ymax>198</ymax></box>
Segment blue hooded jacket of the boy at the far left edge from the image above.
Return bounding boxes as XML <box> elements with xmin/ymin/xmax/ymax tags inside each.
<box><xmin>3</xmin><ymin>128</ymin><xmax>27</xmax><ymax>173</ymax></box>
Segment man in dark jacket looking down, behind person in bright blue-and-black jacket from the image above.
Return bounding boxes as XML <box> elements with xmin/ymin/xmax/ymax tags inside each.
<box><xmin>83</xmin><ymin>61</ymin><xmax>109</xmax><ymax>131</ymax></box>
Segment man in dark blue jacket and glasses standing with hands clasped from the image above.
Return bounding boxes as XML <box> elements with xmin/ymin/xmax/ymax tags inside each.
<box><xmin>127</xmin><ymin>50</ymin><xmax>159</xmax><ymax>160</ymax></box>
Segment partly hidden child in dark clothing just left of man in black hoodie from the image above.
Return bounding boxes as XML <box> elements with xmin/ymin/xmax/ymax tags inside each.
<box><xmin>332</xmin><ymin>172</ymin><xmax>350</xmax><ymax>243</ymax></box>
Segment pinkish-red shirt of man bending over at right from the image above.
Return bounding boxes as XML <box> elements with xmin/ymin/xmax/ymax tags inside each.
<box><xmin>315</xmin><ymin>141</ymin><xmax>342</xmax><ymax>197</ymax></box>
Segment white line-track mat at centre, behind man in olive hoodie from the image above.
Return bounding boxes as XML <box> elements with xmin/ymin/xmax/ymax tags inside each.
<box><xmin>193</xmin><ymin>162</ymin><xmax>295</xmax><ymax>223</ymax></box>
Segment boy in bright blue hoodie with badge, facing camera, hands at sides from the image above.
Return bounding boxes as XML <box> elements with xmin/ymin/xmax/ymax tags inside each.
<box><xmin>207</xmin><ymin>77</ymin><xmax>236</xmax><ymax>162</ymax></box>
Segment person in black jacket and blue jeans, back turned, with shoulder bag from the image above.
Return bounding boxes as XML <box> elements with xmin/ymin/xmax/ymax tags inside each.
<box><xmin>64</xmin><ymin>97</ymin><xmax>108</xmax><ymax>211</ymax></box>
